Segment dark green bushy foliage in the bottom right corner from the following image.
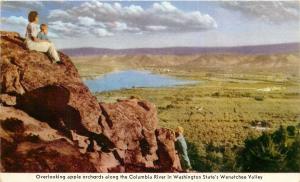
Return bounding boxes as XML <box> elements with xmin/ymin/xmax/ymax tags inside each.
<box><xmin>236</xmin><ymin>126</ymin><xmax>300</xmax><ymax>172</ymax></box>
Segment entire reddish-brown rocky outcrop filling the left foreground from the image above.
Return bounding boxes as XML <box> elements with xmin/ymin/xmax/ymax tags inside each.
<box><xmin>0</xmin><ymin>32</ymin><xmax>181</xmax><ymax>172</ymax></box>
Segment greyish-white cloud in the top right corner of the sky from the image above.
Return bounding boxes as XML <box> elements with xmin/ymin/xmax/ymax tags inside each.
<box><xmin>222</xmin><ymin>1</ymin><xmax>300</xmax><ymax>23</ymax></box>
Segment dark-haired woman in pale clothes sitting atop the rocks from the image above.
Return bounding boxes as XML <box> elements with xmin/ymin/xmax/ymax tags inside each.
<box><xmin>25</xmin><ymin>11</ymin><xmax>61</xmax><ymax>63</ymax></box>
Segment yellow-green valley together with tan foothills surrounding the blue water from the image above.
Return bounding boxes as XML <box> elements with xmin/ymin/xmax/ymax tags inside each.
<box><xmin>73</xmin><ymin>54</ymin><xmax>300</xmax><ymax>149</ymax></box>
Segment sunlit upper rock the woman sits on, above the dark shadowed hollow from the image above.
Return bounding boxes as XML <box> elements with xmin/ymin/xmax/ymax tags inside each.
<box><xmin>0</xmin><ymin>32</ymin><xmax>101</xmax><ymax>133</ymax></box>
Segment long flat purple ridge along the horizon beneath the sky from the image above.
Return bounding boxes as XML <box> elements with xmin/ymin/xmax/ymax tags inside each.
<box><xmin>61</xmin><ymin>43</ymin><xmax>300</xmax><ymax>56</ymax></box>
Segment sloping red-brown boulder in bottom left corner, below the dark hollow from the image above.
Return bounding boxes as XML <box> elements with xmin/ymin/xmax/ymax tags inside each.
<box><xmin>0</xmin><ymin>106</ymin><xmax>96</xmax><ymax>172</ymax></box>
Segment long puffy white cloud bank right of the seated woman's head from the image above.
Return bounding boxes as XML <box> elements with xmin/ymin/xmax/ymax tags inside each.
<box><xmin>48</xmin><ymin>1</ymin><xmax>217</xmax><ymax>37</ymax></box>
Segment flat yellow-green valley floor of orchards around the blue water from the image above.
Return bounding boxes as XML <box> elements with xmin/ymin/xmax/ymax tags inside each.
<box><xmin>75</xmin><ymin>54</ymin><xmax>300</xmax><ymax>154</ymax></box>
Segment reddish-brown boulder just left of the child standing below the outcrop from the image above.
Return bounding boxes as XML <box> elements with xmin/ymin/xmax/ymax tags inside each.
<box><xmin>99</xmin><ymin>99</ymin><xmax>158</xmax><ymax>171</ymax></box>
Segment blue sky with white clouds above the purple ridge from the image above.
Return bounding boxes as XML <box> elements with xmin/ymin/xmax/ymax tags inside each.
<box><xmin>1</xmin><ymin>1</ymin><xmax>300</xmax><ymax>49</ymax></box>
